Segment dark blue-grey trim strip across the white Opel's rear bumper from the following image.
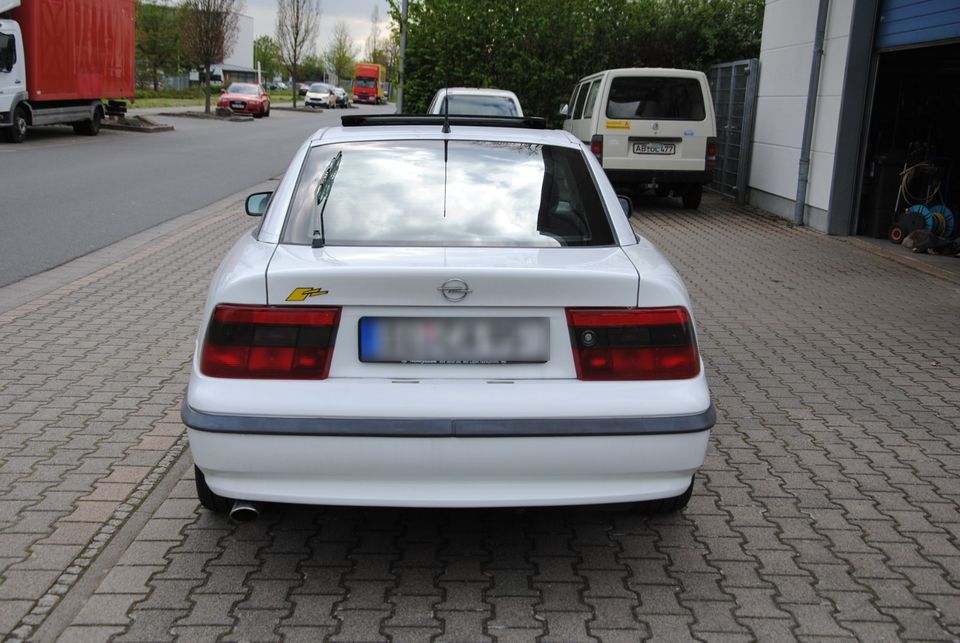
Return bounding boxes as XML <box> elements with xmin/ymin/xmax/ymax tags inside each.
<box><xmin>180</xmin><ymin>400</ymin><xmax>717</xmax><ymax>438</ymax></box>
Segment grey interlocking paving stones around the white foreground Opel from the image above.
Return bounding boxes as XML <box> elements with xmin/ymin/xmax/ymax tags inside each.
<box><xmin>0</xmin><ymin>197</ymin><xmax>960</xmax><ymax>641</ymax></box>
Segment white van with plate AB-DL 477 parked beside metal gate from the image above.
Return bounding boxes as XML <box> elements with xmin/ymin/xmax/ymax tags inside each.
<box><xmin>561</xmin><ymin>67</ymin><xmax>717</xmax><ymax>208</ymax></box>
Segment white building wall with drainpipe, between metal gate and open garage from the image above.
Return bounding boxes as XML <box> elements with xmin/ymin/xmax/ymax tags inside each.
<box><xmin>750</xmin><ymin>0</ymin><xmax>854</xmax><ymax>231</ymax></box>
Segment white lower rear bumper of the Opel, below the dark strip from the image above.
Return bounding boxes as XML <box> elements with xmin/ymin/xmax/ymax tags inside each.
<box><xmin>188</xmin><ymin>429</ymin><xmax>709</xmax><ymax>507</ymax></box>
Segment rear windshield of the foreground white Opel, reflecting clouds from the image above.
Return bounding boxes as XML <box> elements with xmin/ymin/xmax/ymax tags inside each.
<box><xmin>283</xmin><ymin>140</ymin><xmax>614</xmax><ymax>247</ymax></box>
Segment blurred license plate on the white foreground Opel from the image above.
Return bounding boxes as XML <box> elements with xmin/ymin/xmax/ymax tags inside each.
<box><xmin>360</xmin><ymin>317</ymin><xmax>550</xmax><ymax>364</ymax></box>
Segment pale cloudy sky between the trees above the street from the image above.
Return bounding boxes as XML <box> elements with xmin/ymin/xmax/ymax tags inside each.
<box><xmin>243</xmin><ymin>0</ymin><xmax>390</xmax><ymax>55</ymax></box>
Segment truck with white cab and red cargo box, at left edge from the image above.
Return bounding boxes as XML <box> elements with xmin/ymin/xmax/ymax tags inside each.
<box><xmin>0</xmin><ymin>0</ymin><xmax>136</xmax><ymax>143</ymax></box>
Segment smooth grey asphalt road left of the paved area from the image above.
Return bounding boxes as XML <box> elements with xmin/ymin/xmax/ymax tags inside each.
<box><xmin>0</xmin><ymin>105</ymin><xmax>394</xmax><ymax>286</ymax></box>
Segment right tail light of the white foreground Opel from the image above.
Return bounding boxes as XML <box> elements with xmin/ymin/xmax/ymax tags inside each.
<box><xmin>567</xmin><ymin>306</ymin><xmax>700</xmax><ymax>380</ymax></box>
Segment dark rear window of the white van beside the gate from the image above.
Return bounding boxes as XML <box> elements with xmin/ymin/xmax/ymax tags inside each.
<box><xmin>607</xmin><ymin>76</ymin><xmax>706</xmax><ymax>121</ymax></box>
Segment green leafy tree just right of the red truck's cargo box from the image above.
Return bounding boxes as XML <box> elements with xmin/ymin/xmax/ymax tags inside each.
<box><xmin>137</xmin><ymin>0</ymin><xmax>180</xmax><ymax>91</ymax></box>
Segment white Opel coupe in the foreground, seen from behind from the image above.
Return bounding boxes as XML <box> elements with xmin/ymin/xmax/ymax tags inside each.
<box><xmin>182</xmin><ymin>116</ymin><xmax>715</xmax><ymax>518</ymax></box>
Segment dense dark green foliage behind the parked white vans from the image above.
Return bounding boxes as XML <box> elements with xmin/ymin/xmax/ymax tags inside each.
<box><xmin>389</xmin><ymin>0</ymin><xmax>764</xmax><ymax>123</ymax></box>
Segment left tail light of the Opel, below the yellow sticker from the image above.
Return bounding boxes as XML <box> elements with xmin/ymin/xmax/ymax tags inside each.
<box><xmin>200</xmin><ymin>304</ymin><xmax>340</xmax><ymax>380</ymax></box>
